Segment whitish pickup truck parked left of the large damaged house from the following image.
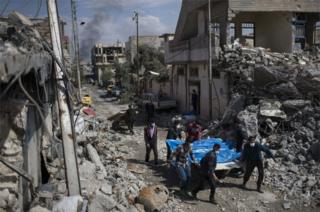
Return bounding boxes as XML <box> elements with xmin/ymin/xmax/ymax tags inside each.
<box><xmin>140</xmin><ymin>93</ymin><xmax>177</xmax><ymax>110</ymax></box>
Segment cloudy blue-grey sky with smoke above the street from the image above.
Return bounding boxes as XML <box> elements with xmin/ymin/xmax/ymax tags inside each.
<box><xmin>0</xmin><ymin>0</ymin><xmax>181</xmax><ymax>57</ymax></box>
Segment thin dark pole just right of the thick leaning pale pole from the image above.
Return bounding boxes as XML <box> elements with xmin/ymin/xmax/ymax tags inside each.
<box><xmin>71</xmin><ymin>0</ymin><xmax>81</xmax><ymax>99</ymax></box>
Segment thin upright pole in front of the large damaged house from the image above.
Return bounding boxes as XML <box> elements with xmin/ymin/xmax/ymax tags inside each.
<box><xmin>208</xmin><ymin>0</ymin><xmax>213</xmax><ymax>119</ymax></box>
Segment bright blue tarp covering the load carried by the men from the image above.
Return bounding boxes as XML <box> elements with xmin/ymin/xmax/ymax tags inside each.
<box><xmin>167</xmin><ymin>138</ymin><xmax>241</xmax><ymax>163</ymax></box>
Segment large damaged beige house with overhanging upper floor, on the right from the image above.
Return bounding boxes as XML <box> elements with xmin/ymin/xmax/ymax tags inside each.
<box><xmin>166</xmin><ymin>0</ymin><xmax>320</xmax><ymax>119</ymax></box>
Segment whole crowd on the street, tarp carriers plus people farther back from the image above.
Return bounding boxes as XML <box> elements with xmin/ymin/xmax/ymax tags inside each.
<box><xmin>124</xmin><ymin>105</ymin><xmax>274</xmax><ymax>204</ymax></box>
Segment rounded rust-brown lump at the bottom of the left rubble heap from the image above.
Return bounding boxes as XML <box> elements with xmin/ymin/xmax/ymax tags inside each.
<box><xmin>138</xmin><ymin>185</ymin><xmax>169</xmax><ymax>211</ymax></box>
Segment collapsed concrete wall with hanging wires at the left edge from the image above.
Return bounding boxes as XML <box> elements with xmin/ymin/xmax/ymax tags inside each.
<box><xmin>0</xmin><ymin>14</ymin><xmax>54</xmax><ymax>211</ymax></box>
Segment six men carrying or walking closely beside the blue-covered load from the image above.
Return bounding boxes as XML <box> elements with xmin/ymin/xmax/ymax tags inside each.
<box><xmin>145</xmin><ymin>118</ymin><xmax>274</xmax><ymax>204</ymax></box>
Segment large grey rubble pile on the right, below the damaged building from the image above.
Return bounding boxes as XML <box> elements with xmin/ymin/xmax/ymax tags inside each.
<box><xmin>220</xmin><ymin>47</ymin><xmax>320</xmax><ymax>205</ymax></box>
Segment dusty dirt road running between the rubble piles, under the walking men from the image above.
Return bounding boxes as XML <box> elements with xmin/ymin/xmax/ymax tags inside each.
<box><xmin>87</xmin><ymin>87</ymin><xmax>317</xmax><ymax>212</ymax></box>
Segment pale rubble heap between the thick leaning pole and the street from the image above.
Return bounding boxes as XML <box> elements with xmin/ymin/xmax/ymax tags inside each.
<box><xmin>47</xmin><ymin>112</ymin><xmax>179</xmax><ymax>212</ymax></box>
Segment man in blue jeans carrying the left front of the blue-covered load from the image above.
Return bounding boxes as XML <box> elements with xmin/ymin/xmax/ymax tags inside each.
<box><xmin>170</xmin><ymin>138</ymin><xmax>194</xmax><ymax>195</ymax></box>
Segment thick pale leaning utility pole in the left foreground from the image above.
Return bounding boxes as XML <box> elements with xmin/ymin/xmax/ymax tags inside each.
<box><xmin>47</xmin><ymin>0</ymin><xmax>81</xmax><ymax>196</ymax></box>
